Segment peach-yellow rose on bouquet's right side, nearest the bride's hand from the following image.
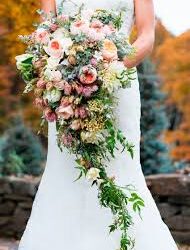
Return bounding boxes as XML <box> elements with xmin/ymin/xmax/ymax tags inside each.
<box><xmin>102</xmin><ymin>39</ymin><xmax>118</xmax><ymax>61</ymax></box>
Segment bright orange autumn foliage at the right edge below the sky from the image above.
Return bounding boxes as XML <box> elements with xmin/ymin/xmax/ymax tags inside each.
<box><xmin>156</xmin><ymin>31</ymin><xmax>190</xmax><ymax>161</ymax></box>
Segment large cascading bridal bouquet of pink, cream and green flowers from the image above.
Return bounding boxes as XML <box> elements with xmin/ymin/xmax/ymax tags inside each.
<box><xmin>16</xmin><ymin>2</ymin><xmax>144</xmax><ymax>250</ymax></box>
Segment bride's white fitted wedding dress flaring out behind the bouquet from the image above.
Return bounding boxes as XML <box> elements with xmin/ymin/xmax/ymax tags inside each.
<box><xmin>19</xmin><ymin>0</ymin><xmax>178</xmax><ymax>250</ymax></box>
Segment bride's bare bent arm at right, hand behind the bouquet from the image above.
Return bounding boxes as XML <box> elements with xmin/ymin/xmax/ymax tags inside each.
<box><xmin>124</xmin><ymin>0</ymin><xmax>155</xmax><ymax>68</ymax></box>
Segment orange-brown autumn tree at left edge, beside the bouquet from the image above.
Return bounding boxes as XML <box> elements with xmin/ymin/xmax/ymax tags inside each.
<box><xmin>0</xmin><ymin>0</ymin><xmax>39</xmax><ymax>132</ymax></box>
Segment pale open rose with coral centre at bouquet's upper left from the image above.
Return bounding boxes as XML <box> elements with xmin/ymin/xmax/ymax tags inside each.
<box><xmin>44</xmin><ymin>39</ymin><xmax>63</xmax><ymax>59</ymax></box>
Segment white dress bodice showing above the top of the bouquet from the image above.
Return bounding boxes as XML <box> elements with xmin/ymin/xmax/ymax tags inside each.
<box><xmin>56</xmin><ymin>0</ymin><xmax>134</xmax><ymax>35</ymax></box>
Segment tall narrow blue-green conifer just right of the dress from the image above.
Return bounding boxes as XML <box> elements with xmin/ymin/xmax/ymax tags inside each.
<box><xmin>138</xmin><ymin>60</ymin><xmax>173</xmax><ymax>174</ymax></box>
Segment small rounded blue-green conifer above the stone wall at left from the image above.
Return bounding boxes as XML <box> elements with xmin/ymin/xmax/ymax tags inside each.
<box><xmin>0</xmin><ymin>119</ymin><xmax>45</xmax><ymax>176</ymax></box>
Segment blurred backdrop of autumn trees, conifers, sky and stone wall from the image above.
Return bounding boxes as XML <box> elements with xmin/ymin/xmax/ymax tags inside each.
<box><xmin>0</xmin><ymin>0</ymin><xmax>190</xmax><ymax>250</ymax></box>
